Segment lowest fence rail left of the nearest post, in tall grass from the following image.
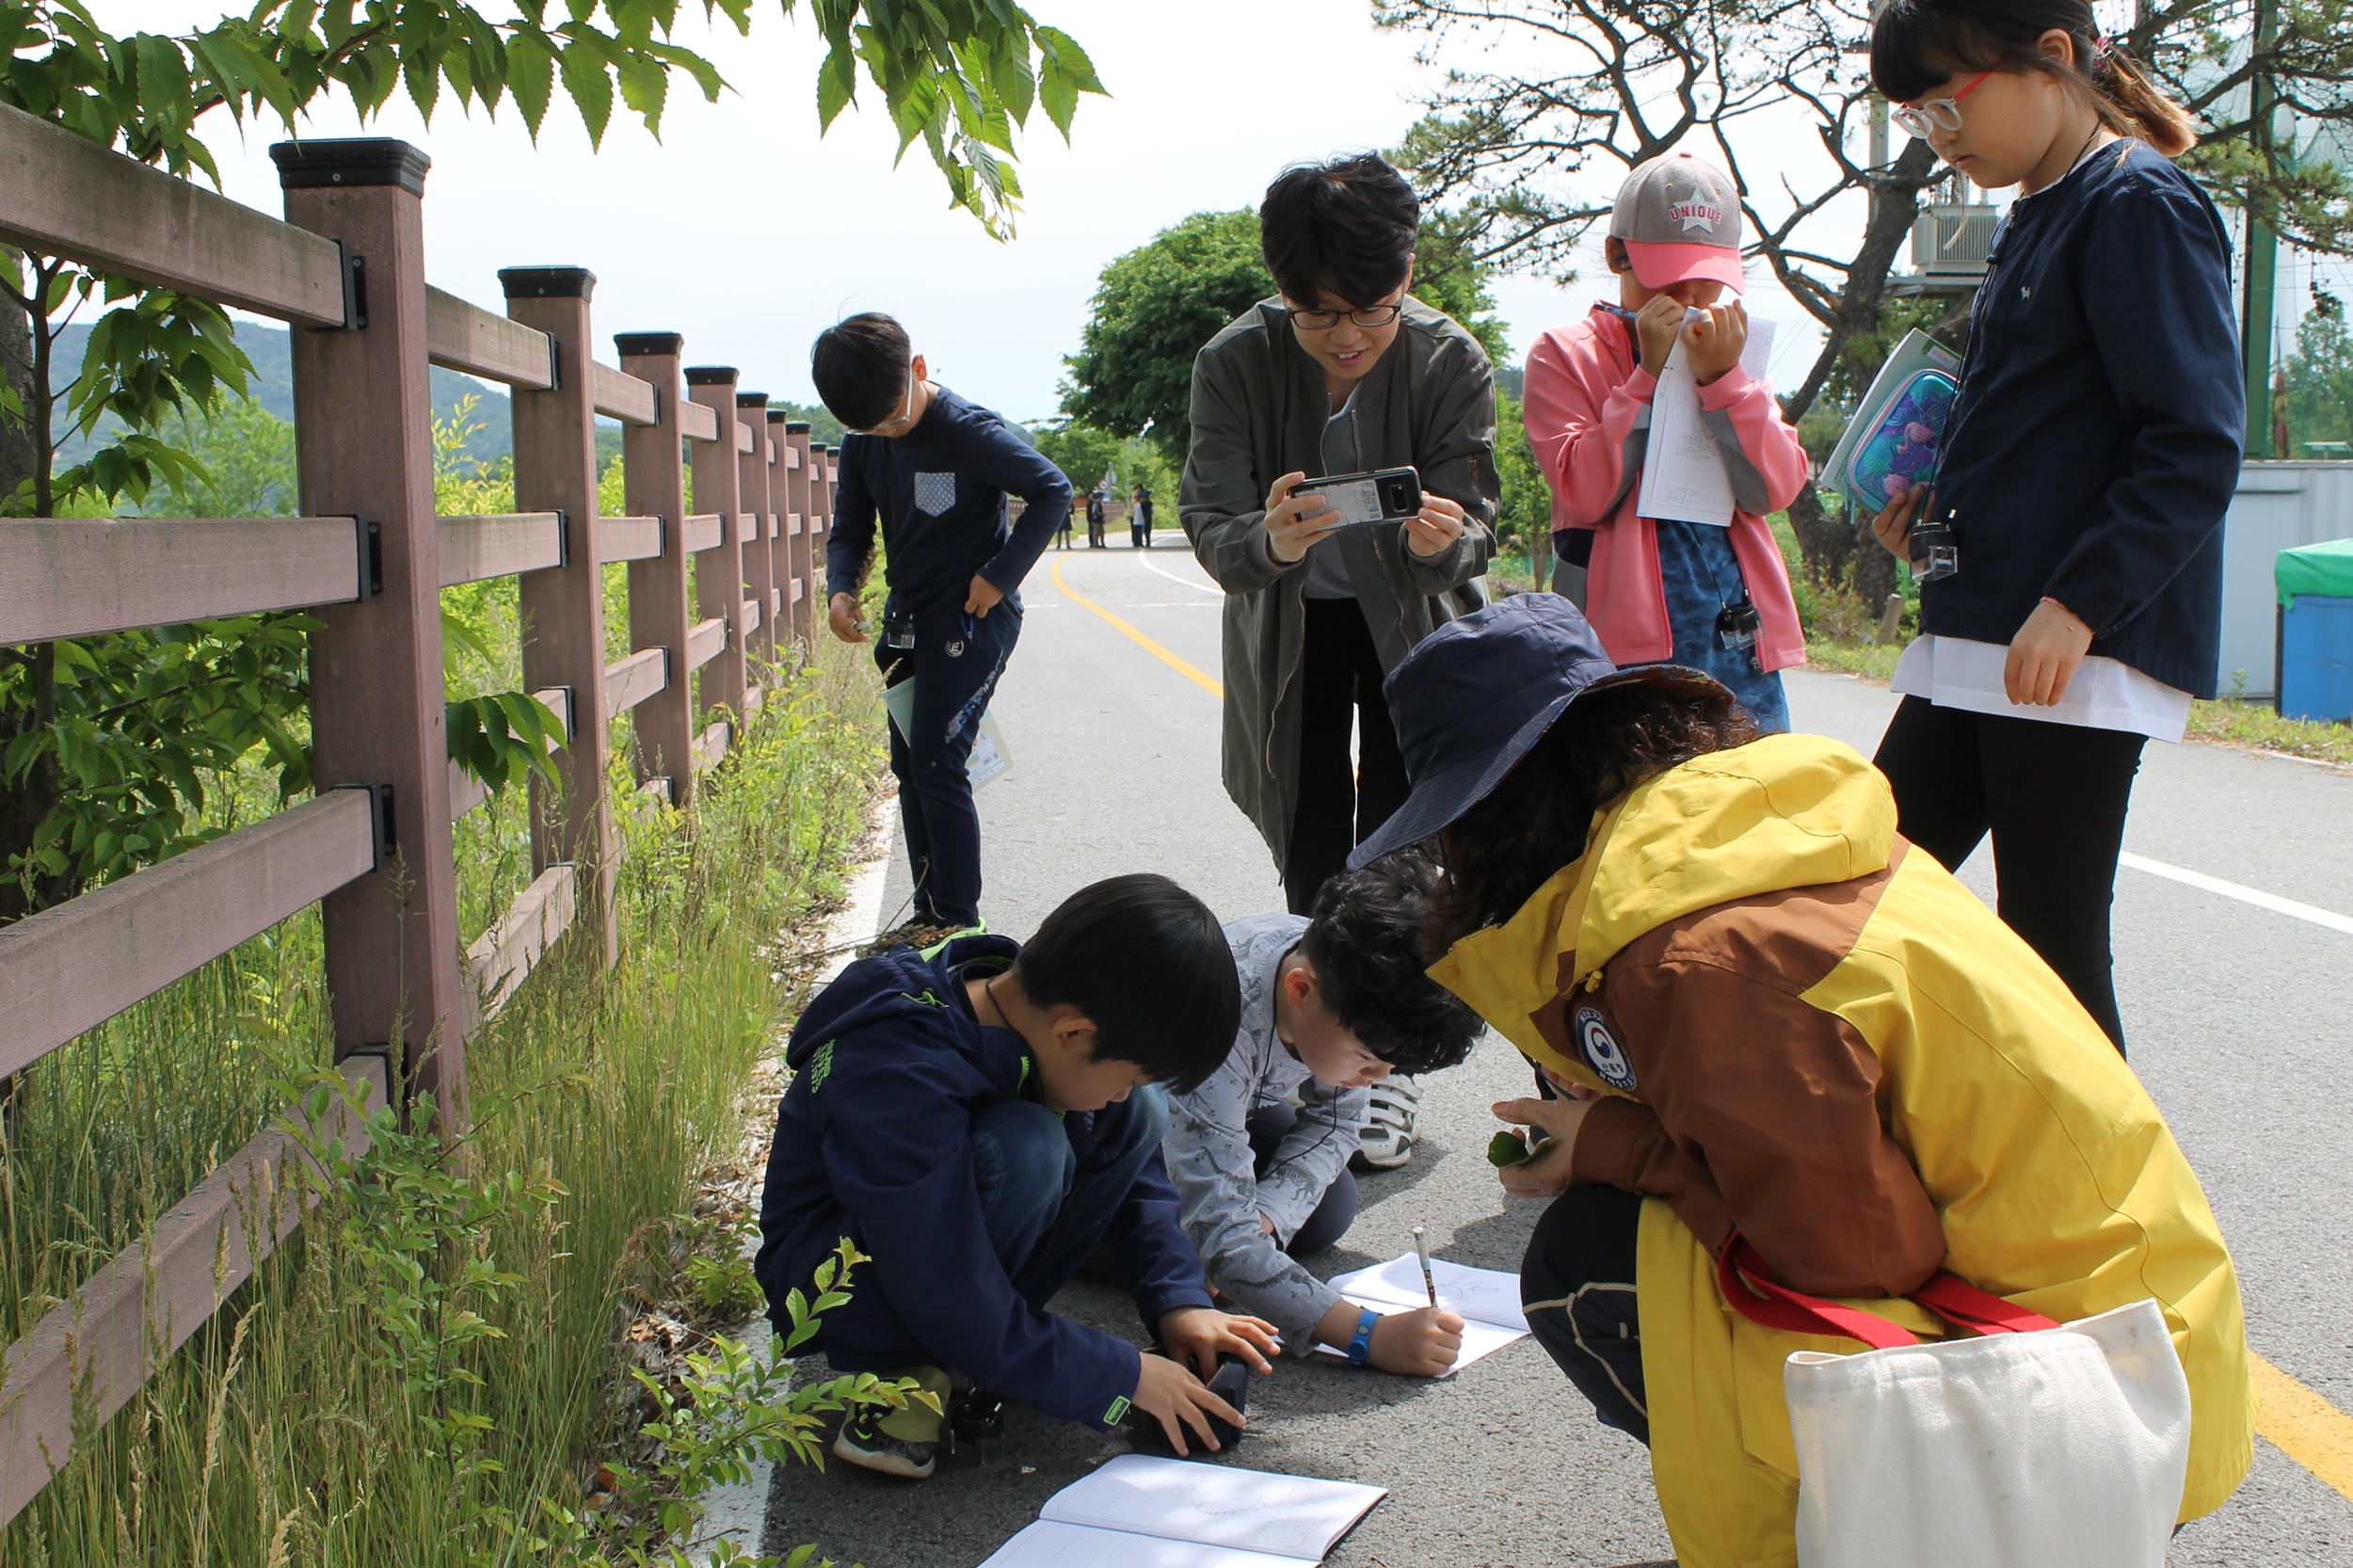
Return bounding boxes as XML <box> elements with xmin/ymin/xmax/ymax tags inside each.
<box><xmin>0</xmin><ymin>1057</ymin><xmax>389</xmax><ymax>1526</ymax></box>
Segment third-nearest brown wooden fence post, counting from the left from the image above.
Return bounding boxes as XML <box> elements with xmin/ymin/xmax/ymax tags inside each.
<box><xmin>612</xmin><ymin>332</ymin><xmax>695</xmax><ymax>808</ymax></box>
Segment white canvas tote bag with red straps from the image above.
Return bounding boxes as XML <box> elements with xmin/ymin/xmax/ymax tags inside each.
<box><xmin>1718</xmin><ymin>1236</ymin><xmax>2191</xmax><ymax>1568</ymax></box>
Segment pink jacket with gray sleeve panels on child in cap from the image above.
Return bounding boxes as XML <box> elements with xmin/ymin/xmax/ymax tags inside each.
<box><xmin>1525</xmin><ymin>309</ymin><xmax>1810</xmax><ymax>671</ymax></box>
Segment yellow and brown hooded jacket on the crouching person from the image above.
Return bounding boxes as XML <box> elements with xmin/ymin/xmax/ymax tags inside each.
<box><xmin>1431</xmin><ymin>734</ymin><xmax>2254</xmax><ymax>1568</ymax></box>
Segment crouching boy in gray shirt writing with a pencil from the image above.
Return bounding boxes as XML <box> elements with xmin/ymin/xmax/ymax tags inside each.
<box><xmin>1162</xmin><ymin>853</ymin><xmax>1481</xmax><ymax>1377</ymax></box>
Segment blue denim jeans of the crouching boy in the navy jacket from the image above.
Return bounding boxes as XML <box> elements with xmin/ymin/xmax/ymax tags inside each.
<box><xmin>972</xmin><ymin>1083</ymin><xmax>1170</xmax><ymax>1306</ymax></box>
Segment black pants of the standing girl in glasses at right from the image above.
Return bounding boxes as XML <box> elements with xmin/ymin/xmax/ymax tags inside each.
<box><xmin>1876</xmin><ymin>696</ymin><xmax>2149</xmax><ymax>1050</ymax></box>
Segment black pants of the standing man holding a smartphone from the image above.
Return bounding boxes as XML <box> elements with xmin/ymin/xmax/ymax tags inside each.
<box><xmin>1283</xmin><ymin>598</ymin><xmax>1405</xmax><ymax>914</ymax></box>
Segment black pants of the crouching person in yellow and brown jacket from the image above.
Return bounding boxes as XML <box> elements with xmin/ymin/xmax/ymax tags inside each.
<box><xmin>1520</xmin><ymin>1187</ymin><xmax>1650</xmax><ymax>1443</ymax></box>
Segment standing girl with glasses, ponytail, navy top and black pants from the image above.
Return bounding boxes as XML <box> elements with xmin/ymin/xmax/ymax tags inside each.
<box><xmin>1871</xmin><ymin>0</ymin><xmax>2248</xmax><ymax>1050</ymax></box>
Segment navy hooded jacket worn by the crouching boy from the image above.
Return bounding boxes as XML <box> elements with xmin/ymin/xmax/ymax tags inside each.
<box><xmin>753</xmin><ymin>937</ymin><xmax>1209</xmax><ymax>1432</ymax></box>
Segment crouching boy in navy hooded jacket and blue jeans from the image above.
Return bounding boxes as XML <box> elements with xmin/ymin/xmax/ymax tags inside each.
<box><xmin>756</xmin><ymin>876</ymin><xmax>1275</xmax><ymax>1479</ymax></box>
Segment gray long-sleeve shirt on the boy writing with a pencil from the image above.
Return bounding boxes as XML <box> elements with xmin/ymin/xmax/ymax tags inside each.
<box><xmin>1160</xmin><ymin>914</ymin><xmax>1372</xmax><ymax>1356</ymax></box>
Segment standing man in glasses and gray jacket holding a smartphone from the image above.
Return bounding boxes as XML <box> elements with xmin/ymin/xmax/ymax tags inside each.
<box><xmin>1179</xmin><ymin>153</ymin><xmax>1499</xmax><ymax>1165</ymax></box>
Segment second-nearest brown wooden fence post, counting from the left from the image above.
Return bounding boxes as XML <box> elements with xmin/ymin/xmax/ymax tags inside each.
<box><xmin>499</xmin><ymin>266</ymin><xmax>621</xmax><ymax>966</ymax></box>
